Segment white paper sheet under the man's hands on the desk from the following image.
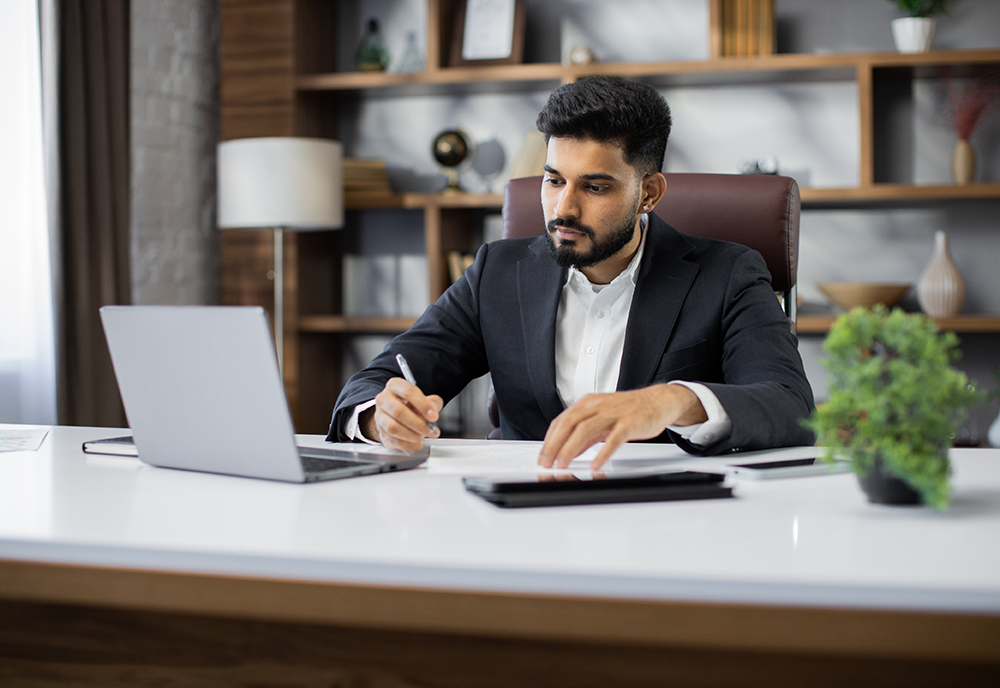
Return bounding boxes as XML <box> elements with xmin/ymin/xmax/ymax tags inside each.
<box><xmin>427</xmin><ymin>440</ymin><xmax>690</xmax><ymax>475</ymax></box>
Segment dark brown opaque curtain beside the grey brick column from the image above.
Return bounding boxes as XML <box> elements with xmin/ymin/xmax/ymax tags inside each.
<box><xmin>50</xmin><ymin>0</ymin><xmax>131</xmax><ymax>427</ymax></box>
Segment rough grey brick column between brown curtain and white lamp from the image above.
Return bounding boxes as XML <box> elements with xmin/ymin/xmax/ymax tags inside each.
<box><xmin>131</xmin><ymin>0</ymin><xmax>220</xmax><ymax>304</ymax></box>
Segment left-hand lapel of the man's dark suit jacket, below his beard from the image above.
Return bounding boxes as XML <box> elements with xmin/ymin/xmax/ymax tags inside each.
<box><xmin>515</xmin><ymin>237</ymin><xmax>566</xmax><ymax>418</ymax></box>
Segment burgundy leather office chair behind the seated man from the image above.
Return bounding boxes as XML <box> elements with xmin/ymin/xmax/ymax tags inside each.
<box><xmin>488</xmin><ymin>173</ymin><xmax>801</xmax><ymax>439</ymax></box>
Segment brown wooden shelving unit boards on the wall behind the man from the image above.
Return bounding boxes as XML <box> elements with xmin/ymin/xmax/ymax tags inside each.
<box><xmin>222</xmin><ymin>0</ymin><xmax>1000</xmax><ymax>432</ymax></box>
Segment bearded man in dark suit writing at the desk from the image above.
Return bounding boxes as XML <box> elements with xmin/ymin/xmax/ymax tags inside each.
<box><xmin>328</xmin><ymin>77</ymin><xmax>813</xmax><ymax>469</ymax></box>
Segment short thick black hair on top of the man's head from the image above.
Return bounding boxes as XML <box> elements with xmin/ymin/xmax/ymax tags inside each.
<box><xmin>535</xmin><ymin>76</ymin><xmax>671</xmax><ymax>176</ymax></box>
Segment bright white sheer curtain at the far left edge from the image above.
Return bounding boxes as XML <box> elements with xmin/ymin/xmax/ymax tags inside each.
<box><xmin>0</xmin><ymin>0</ymin><xmax>56</xmax><ymax>425</ymax></box>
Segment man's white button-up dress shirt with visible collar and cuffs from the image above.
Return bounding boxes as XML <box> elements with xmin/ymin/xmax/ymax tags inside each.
<box><xmin>344</xmin><ymin>215</ymin><xmax>732</xmax><ymax>446</ymax></box>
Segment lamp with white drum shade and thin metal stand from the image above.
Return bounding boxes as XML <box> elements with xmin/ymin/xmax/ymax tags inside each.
<box><xmin>218</xmin><ymin>137</ymin><xmax>344</xmax><ymax>370</ymax></box>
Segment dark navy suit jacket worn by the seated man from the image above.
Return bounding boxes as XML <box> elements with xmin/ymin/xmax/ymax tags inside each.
<box><xmin>328</xmin><ymin>214</ymin><xmax>814</xmax><ymax>454</ymax></box>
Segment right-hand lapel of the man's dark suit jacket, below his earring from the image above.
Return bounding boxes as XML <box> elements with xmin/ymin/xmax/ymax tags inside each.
<box><xmin>618</xmin><ymin>213</ymin><xmax>698</xmax><ymax>390</ymax></box>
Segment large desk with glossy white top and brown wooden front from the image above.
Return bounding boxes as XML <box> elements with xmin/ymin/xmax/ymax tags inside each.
<box><xmin>0</xmin><ymin>428</ymin><xmax>1000</xmax><ymax>685</ymax></box>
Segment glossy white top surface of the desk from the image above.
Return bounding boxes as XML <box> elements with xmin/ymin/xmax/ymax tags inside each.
<box><xmin>0</xmin><ymin>427</ymin><xmax>1000</xmax><ymax>615</ymax></box>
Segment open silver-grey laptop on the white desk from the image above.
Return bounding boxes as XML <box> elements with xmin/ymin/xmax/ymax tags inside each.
<box><xmin>101</xmin><ymin>306</ymin><xmax>430</xmax><ymax>483</ymax></box>
